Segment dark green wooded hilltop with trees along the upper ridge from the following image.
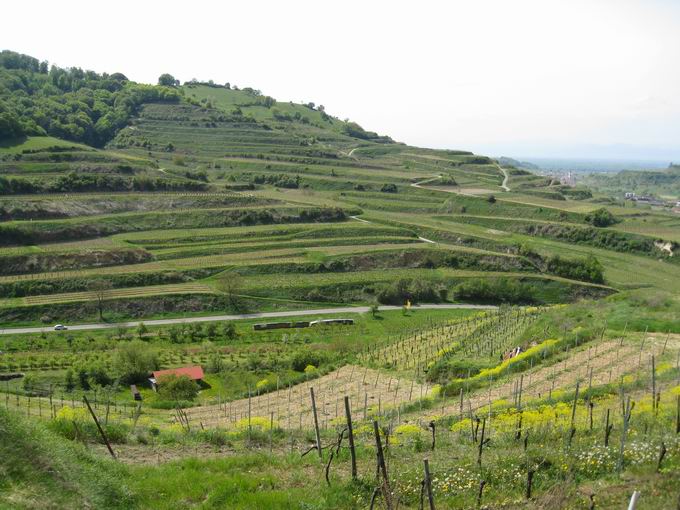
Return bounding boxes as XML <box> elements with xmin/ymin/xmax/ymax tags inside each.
<box><xmin>0</xmin><ymin>50</ymin><xmax>391</xmax><ymax>147</ymax></box>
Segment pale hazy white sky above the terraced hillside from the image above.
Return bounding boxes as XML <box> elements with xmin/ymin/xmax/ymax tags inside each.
<box><xmin>0</xmin><ymin>0</ymin><xmax>680</xmax><ymax>161</ymax></box>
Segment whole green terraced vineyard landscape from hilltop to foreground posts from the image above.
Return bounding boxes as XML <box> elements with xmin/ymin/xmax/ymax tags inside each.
<box><xmin>0</xmin><ymin>47</ymin><xmax>680</xmax><ymax>509</ymax></box>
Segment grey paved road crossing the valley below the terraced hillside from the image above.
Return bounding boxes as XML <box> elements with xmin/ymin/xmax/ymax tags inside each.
<box><xmin>0</xmin><ymin>304</ymin><xmax>496</xmax><ymax>335</ymax></box>
